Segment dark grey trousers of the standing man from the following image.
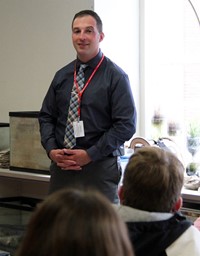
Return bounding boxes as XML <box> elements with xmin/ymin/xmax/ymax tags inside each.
<box><xmin>49</xmin><ymin>157</ymin><xmax>122</xmax><ymax>203</ymax></box>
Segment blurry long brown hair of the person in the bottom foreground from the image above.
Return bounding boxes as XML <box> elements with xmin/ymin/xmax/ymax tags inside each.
<box><xmin>16</xmin><ymin>189</ymin><xmax>134</xmax><ymax>256</ymax></box>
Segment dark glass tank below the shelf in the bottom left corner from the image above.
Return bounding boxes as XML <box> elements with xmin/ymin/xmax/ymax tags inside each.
<box><xmin>0</xmin><ymin>197</ymin><xmax>40</xmax><ymax>256</ymax></box>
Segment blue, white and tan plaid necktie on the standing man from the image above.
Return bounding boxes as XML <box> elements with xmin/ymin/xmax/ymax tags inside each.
<box><xmin>64</xmin><ymin>64</ymin><xmax>87</xmax><ymax>148</ymax></box>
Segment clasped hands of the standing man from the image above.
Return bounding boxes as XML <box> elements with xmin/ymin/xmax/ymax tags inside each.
<box><xmin>49</xmin><ymin>148</ymin><xmax>91</xmax><ymax>171</ymax></box>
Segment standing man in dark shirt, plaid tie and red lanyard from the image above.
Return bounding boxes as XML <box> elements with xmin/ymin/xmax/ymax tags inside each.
<box><xmin>39</xmin><ymin>10</ymin><xmax>136</xmax><ymax>202</ymax></box>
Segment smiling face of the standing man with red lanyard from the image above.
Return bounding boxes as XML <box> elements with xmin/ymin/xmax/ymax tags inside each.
<box><xmin>72</xmin><ymin>15</ymin><xmax>104</xmax><ymax>62</ymax></box>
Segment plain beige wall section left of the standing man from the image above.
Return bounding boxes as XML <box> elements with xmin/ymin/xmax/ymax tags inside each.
<box><xmin>0</xmin><ymin>0</ymin><xmax>94</xmax><ymax>122</ymax></box>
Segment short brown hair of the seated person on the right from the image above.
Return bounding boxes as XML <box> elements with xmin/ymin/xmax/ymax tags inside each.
<box><xmin>123</xmin><ymin>147</ymin><xmax>184</xmax><ymax>212</ymax></box>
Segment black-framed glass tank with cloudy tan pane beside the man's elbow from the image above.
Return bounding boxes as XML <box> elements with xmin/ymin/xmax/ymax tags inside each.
<box><xmin>9</xmin><ymin>111</ymin><xmax>50</xmax><ymax>173</ymax></box>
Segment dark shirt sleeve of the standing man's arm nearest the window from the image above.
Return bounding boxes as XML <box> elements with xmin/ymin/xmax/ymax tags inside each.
<box><xmin>87</xmin><ymin>73</ymin><xmax>136</xmax><ymax>161</ymax></box>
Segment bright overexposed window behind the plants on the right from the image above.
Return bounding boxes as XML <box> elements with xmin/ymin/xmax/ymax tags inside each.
<box><xmin>140</xmin><ymin>0</ymin><xmax>200</xmax><ymax>163</ymax></box>
